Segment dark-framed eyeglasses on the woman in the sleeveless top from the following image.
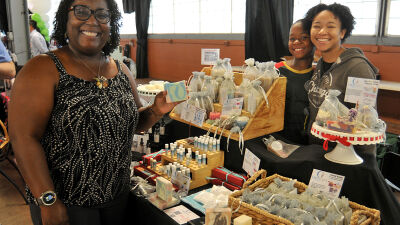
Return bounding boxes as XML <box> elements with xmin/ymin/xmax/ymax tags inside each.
<box><xmin>69</xmin><ymin>5</ymin><xmax>111</xmax><ymax>23</ymax></box>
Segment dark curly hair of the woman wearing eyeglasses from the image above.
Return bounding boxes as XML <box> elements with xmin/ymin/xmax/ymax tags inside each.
<box><xmin>51</xmin><ymin>0</ymin><xmax>121</xmax><ymax>55</ymax></box>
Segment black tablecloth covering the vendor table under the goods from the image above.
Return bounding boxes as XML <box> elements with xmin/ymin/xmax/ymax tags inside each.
<box><xmin>129</xmin><ymin>121</ymin><xmax>400</xmax><ymax>225</ymax></box>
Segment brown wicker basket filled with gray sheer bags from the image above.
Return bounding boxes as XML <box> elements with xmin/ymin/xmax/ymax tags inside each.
<box><xmin>229</xmin><ymin>170</ymin><xmax>380</xmax><ymax>225</ymax></box>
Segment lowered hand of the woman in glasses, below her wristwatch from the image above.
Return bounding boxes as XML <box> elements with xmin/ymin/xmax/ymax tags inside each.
<box><xmin>40</xmin><ymin>201</ymin><xmax>69</xmax><ymax>225</ymax></box>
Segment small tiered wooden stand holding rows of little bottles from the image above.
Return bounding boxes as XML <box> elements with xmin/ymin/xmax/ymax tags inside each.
<box><xmin>147</xmin><ymin>139</ymin><xmax>224</xmax><ymax>190</ymax></box>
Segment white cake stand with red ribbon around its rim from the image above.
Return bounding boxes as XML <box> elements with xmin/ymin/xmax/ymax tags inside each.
<box><xmin>311</xmin><ymin>122</ymin><xmax>385</xmax><ymax>165</ymax></box>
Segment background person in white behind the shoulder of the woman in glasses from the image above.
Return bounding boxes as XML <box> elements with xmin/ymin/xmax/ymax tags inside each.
<box><xmin>29</xmin><ymin>19</ymin><xmax>49</xmax><ymax>57</ymax></box>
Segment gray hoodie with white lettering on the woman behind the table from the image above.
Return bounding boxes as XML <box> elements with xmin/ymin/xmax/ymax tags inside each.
<box><xmin>305</xmin><ymin>48</ymin><xmax>378</xmax><ymax>153</ymax></box>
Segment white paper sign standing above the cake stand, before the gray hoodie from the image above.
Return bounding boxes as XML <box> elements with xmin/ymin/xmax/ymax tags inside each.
<box><xmin>344</xmin><ymin>77</ymin><xmax>379</xmax><ymax>107</ymax></box>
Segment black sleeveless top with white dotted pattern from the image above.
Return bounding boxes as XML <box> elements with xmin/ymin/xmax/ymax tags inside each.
<box><xmin>26</xmin><ymin>52</ymin><xmax>139</xmax><ymax>207</ymax></box>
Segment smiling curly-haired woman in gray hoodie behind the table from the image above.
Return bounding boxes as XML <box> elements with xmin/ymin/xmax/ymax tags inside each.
<box><xmin>305</xmin><ymin>3</ymin><xmax>378</xmax><ymax>154</ymax></box>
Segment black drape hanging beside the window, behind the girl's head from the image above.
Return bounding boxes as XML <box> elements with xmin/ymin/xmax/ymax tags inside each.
<box><xmin>245</xmin><ymin>0</ymin><xmax>294</xmax><ymax>62</ymax></box>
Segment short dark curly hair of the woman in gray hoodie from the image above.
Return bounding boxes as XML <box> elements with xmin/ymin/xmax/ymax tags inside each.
<box><xmin>304</xmin><ymin>3</ymin><xmax>356</xmax><ymax>42</ymax></box>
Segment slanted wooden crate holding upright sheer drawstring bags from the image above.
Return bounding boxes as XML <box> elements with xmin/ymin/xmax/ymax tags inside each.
<box><xmin>170</xmin><ymin>77</ymin><xmax>287</xmax><ymax>140</ymax></box>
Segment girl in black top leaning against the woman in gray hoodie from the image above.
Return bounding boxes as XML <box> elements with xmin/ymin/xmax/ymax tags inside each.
<box><xmin>275</xmin><ymin>19</ymin><xmax>314</xmax><ymax>145</ymax></box>
